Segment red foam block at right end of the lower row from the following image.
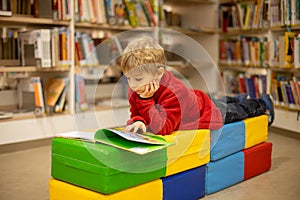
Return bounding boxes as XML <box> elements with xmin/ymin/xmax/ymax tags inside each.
<box><xmin>243</xmin><ymin>142</ymin><xmax>272</xmax><ymax>180</ymax></box>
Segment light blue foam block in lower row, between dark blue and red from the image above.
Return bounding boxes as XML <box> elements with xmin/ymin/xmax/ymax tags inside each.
<box><xmin>205</xmin><ymin>151</ymin><xmax>244</xmax><ymax>194</ymax></box>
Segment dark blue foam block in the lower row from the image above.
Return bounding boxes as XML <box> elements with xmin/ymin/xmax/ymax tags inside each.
<box><xmin>162</xmin><ymin>166</ymin><xmax>205</xmax><ymax>200</ymax></box>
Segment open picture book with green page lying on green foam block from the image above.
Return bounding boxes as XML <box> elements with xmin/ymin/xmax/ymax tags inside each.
<box><xmin>56</xmin><ymin>129</ymin><xmax>172</xmax><ymax>154</ymax></box>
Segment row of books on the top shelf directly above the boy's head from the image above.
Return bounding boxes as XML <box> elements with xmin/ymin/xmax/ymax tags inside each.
<box><xmin>75</xmin><ymin>0</ymin><xmax>159</xmax><ymax>27</ymax></box>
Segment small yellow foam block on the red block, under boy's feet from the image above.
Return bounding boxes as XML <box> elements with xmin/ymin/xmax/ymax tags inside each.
<box><xmin>243</xmin><ymin>115</ymin><xmax>268</xmax><ymax>149</ymax></box>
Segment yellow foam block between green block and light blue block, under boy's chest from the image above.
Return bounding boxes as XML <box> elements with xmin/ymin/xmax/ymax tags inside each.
<box><xmin>164</xmin><ymin>129</ymin><xmax>210</xmax><ymax>176</ymax></box>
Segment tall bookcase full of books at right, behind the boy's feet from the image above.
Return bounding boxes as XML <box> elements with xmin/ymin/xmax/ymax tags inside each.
<box><xmin>219</xmin><ymin>0</ymin><xmax>300</xmax><ymax>132</ymax></box>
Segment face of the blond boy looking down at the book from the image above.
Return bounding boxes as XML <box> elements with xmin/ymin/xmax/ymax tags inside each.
<box><xmin>125</xmin><ymin>70</ymin><xmax>161</xmax><ymax>95</ymax></box>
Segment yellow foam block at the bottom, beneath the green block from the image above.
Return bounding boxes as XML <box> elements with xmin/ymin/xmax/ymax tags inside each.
<box><xmin>49</xmin><ymin>178</ymin><xmax>163</xmax><ymax>200</ymax></box>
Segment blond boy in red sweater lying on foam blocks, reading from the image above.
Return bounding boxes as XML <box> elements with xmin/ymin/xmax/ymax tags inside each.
<box><xmin>121</xmin><ymin>37</ymin><xmax>274</xmax><ymax>135</ymax></box>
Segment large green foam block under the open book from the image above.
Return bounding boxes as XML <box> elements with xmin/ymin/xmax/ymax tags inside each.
<box><xmin>51</xmin><ymin>138</ymin><xmax>167</xmax><ymax>194</ymax></box>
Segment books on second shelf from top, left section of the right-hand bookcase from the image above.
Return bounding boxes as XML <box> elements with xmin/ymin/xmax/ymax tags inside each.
<box><xmin>219</xmin><ymin>36</ymin><xmax>269</xmax><ymax>67</ymax></box>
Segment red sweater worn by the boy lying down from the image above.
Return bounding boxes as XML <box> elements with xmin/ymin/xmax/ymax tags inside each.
<box><xmin>127</xmin><ymin>71</ymin><xmax>223</xmax><ymax>135</ymax></box>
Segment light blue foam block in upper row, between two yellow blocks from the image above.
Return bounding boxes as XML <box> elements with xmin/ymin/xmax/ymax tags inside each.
<box><xmin>210</xmin><ymin>121</ymin><xmax>245</xmax><ymax>161</ymax></box>
